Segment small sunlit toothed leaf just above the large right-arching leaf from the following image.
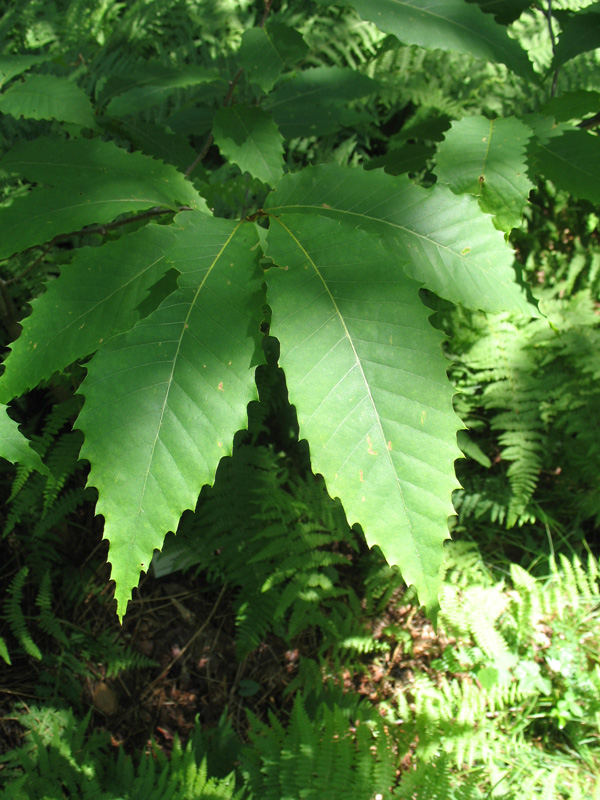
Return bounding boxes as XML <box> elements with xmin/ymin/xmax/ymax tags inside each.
<box><xmin>435</xmin><ymin>117</ymin><xmax>533</xmax><ymax>231</ymax></box>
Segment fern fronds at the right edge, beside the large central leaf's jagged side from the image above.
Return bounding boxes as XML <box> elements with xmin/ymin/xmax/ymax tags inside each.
<box><xmin>455</xmin><ymin>291</ymin><xmax>600</xmax><ymax>527</ymax></box>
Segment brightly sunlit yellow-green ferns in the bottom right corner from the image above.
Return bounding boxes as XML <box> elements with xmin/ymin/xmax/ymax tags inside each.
<box><xmin>395</xmin><ymin>542</ymin><xmax>600</xmax><ymax>800</ymax></box>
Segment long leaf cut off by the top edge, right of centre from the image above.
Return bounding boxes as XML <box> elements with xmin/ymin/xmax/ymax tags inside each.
<box><xmin>324</xmin><ymin>0</ymin><xmax>538</xmax><ymax>81</ymax></box>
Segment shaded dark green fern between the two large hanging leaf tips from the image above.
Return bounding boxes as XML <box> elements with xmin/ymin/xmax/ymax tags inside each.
<box><xmin>163</xmin><ymin>444</ymin><xmax>361</xmax><ymax>657</ymax></box>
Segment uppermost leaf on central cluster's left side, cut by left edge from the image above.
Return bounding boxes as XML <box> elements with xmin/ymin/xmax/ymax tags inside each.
<box><xmin>0</xmin><ymin>137</ymin><xmax>206</xmax><ymax>258</ymax></box>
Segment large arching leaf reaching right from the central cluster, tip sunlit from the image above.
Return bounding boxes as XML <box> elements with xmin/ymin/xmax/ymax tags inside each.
<box><xmin>264</xmin><ymin>164</ymin><xmax>539</xmax><ymax>316</ymax></box>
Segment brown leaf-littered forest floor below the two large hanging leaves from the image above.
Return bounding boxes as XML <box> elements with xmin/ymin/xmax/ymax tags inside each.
<box><xmin>0</xmin><ymin>520</ymin><xmax>446</xmax><ymax>754</ymax></box>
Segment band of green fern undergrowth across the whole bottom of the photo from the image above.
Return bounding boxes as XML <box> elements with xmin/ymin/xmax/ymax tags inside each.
<box><xmin>0</xmin><ymin>542</ymin><xmax>600</xmax><ymax>800</ymax></box>
